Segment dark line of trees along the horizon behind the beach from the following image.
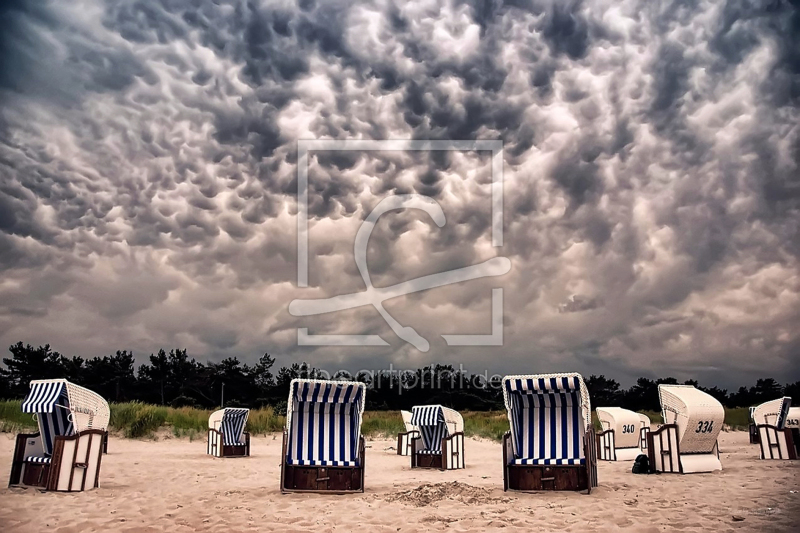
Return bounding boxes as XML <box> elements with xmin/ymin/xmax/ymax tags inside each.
<box><xmin>0</xmin><ymin>342</ymin><xmax>800</xmax><ymax>411</ymax></box>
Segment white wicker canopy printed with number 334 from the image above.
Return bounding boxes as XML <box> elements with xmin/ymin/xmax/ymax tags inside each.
<box><xmin>658</xmin><ymin>385</ymin><xmax>725</xmax><ymax>455</ymax></box>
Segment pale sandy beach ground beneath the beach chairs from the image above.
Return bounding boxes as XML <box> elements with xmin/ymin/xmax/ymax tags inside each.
<box><xmin>0</xmin><ymin>432</ymin><xmax>800</xmax><ymax>533</ymax></box>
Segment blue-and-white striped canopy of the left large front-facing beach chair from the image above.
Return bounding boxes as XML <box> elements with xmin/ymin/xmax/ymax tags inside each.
<box><xmin>286</xmin><ymin>379</ymin><xmax>366</xmax><ymax>466</ymax></box>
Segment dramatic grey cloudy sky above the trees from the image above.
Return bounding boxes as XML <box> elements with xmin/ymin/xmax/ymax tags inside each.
<box><xmin>0</xmin><ymin>0</ymin><xmax>800</xmax><ymax>386</ymax></box>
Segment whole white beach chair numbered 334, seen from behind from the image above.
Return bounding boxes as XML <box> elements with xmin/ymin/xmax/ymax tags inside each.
<box><xmin>647</xmin><ymin>385</ymin><xmax>725</xmax><ymax>474</ymax></box>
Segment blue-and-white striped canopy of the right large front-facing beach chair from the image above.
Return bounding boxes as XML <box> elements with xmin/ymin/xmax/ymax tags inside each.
<box><xmin>503</xmin><ymin>373</ymin><xmax>591</xmax><ymax>465</ymax></box>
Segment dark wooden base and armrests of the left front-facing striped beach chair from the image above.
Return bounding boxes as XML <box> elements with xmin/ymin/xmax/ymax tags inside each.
<box><xmin>281</xmin><ymin>431</ymin><xmax>366</xmax><ymax>494</ymax></box>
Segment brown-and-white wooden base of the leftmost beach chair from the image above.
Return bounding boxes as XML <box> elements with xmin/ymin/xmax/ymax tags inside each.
<box><xmin>8</xmin><ymin>429</ymin><xmax>106</xmax><ymax>492</ymax></box>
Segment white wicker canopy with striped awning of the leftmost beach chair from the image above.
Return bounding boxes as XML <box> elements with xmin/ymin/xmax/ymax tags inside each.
<box><xmin>22</xmin><ymin>379</ymin><xmax>110</xmax><ymax>455</ymax></box>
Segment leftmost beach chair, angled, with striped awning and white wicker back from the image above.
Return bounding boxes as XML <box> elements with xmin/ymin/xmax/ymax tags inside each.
<box><xmin>8</xmin><ymin>379</ymin><xmax>110</xmax><ymax>492</ymax></box>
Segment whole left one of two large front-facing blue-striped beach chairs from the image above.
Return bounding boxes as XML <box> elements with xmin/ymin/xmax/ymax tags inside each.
<box><xmin>281</xmin><ymin>379</ymin><xmax>366</xmax><ymax>493</ymax></box>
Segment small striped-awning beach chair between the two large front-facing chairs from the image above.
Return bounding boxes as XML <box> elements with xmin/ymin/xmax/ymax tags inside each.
<box><xmin>411</xmin><ymin>405</ymin><xmax>466</xmax><ymax>470</ymax></box>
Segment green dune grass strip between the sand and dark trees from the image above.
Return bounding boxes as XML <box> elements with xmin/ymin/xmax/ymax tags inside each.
<box><xmin>0</xmin><ymin>400</ymin><xmax>749</xmax><ymax>441</ymax></box>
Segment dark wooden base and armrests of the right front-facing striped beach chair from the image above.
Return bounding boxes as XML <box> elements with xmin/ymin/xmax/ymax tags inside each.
<box><xmin>503</xmin><ymin>430</ymin><xmax>597</xmax><ymax>493</ymax></box>
